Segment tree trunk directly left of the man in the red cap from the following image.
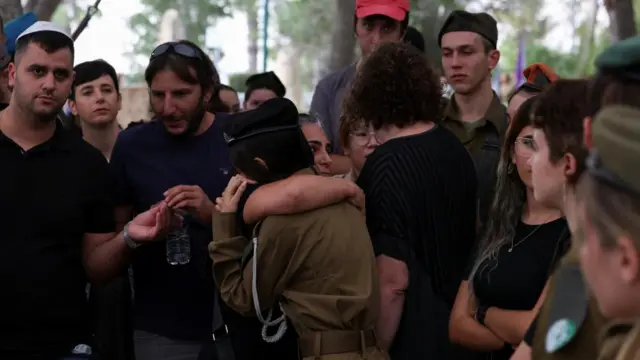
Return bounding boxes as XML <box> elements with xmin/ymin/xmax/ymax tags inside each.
<box><xmin>322</xmin><ymin>0</ymin><xmax>356</xmax><ymax>75</ymax></box>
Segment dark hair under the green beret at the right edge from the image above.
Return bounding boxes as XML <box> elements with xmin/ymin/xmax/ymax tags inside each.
<box><xmin>586</xmin><ymin>71</ymin><xmax>640</xmax><ymax>118</ymax></box>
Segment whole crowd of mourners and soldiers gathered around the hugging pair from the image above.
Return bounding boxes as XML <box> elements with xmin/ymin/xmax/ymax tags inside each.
<box><xmin>0</xmin><ymin>0</ymin><xmax>640</xmax><ymax>360</ymax></box>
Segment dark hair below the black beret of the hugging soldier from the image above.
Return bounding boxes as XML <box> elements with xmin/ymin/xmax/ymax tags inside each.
<box><xmin>229</xmin><ymin>128</ymin><xmax>313</xmax><ymax>184</ymax></box>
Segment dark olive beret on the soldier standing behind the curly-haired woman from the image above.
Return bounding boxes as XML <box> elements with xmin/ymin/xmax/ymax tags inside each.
<box><xmin>438</xmin><ymin>10</ymin><xmax>498</xmax><ymax>47</ymax></box>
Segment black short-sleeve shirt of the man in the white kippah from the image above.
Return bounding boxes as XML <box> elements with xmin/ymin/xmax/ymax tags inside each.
<box><xmin>0</xmin><ymin>125</ymin><xmax>115</xmax><ymax>359</ymax></box>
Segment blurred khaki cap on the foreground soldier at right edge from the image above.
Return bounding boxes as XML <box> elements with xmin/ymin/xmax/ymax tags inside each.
<box><xmin>587</xmin><ymin>105</ymin><xmax>640</xmax><ymax>194</ymax></box>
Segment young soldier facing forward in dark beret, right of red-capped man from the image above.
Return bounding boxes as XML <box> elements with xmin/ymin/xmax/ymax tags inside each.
<box><xmin>438</xmin><ymin>10</ymin><xmax>508</xmax><ymax>222</ymax></box>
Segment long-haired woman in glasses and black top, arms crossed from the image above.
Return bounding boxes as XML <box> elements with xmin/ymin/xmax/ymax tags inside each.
<box><xmin>449</xmin><ymin>97</ymin><xmax>569</xmax><ymax>360</ymax></box>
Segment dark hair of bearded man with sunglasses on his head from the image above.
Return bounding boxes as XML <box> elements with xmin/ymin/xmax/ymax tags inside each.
<box><xmin>144</xmin><ymin>40</ymin><xmax>220</xmax><ymax>91</ymax></box>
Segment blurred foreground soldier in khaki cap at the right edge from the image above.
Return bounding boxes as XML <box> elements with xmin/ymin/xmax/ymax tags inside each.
<box><xmin>575</xmin><ymin>105</ymin><xmax>640</xmax><ymax>360</ymax></box>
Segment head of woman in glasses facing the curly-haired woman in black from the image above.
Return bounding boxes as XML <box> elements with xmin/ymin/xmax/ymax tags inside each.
<box><xmin>338</xmin><ymin>117</ymin><xmax>378</xmax><ymax>182</ymax></box>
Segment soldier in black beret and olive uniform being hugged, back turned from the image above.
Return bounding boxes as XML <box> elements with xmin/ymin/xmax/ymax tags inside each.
<box><xmin>210</xmin><ymin>98</ymin><xmax>388</xmax><ymax>360</ymax></box>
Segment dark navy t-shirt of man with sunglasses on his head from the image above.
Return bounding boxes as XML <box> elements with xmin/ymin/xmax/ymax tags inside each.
<box><xmin>109</xmin><ymin>121</ymin><xmax>233</xmax><ymax>341</ymax></box>
